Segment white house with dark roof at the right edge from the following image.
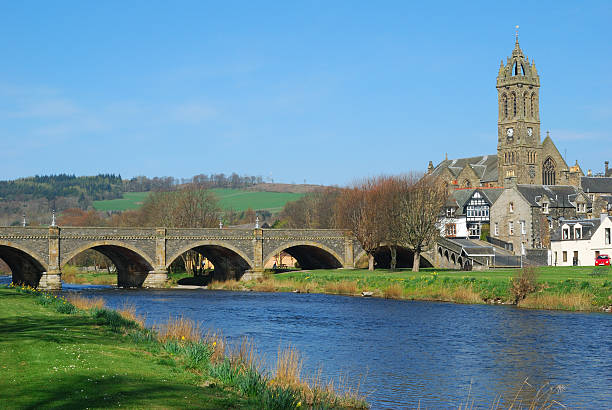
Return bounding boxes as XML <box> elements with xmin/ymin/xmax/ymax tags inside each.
<box><xmin>549</xmin><ymin>214</ymin><xmax>612</xmax><ymax>266</ymax></box>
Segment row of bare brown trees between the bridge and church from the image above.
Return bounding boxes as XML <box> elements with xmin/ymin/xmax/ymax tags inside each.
<box><xmin>275</xmin><ymin>175</ymin><xmax>448</xmax><ymax>271</ymax></box>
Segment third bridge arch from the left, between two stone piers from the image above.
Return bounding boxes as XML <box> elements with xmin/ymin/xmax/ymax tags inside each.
<box><xmin>165</xmin><ymin>240</ymin><xmax>254</xmax><ymax>280</ymax></box>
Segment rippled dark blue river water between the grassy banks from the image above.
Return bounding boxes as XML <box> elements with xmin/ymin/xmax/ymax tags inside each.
<box><xmin>2</xmin><ymin>276</ymin><xmax>612</xmax><ymax>409</ymax></box>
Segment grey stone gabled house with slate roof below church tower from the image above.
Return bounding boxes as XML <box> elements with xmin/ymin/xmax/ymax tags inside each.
<box><xmin>490</xmin><ymin>184</ymin><xmax>591</xmax><ymax>254</ymax></box>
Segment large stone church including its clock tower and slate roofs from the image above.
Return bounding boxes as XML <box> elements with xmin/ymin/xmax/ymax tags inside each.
<box><xmin>427</xmin><ymin>33</ymin><xmax>584</xmax><ymax>188</ymax></box>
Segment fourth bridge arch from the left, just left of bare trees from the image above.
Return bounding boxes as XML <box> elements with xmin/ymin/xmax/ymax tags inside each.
<box><xmin>263</xmin><ymin>240</ymin><xmax>344</xmax><ymax>269</ymax></box>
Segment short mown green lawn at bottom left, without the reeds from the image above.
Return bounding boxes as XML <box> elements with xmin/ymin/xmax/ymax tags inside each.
<box><xmin>0</xmin><ymin>288</ymin><xmax>254</xmax><ymax>409</ymax></box>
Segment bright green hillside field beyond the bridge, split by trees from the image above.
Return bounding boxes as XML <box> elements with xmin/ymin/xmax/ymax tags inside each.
<box><xmin>94</xmin><ymin>188</ymin><xmax>304</xmax><ymax>213</ymax></box>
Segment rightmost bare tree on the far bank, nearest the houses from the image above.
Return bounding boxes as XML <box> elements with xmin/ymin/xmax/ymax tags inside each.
<box><xmin>400</xmin><ymin>175</ymin><xmax>448</xmax><ymax>272</ymax></box>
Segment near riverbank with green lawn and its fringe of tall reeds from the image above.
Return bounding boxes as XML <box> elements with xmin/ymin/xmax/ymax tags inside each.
<box><xmin>0</xmin><ymin>287</ymin><xmax>365</xmax><ymax>409</ymax></box>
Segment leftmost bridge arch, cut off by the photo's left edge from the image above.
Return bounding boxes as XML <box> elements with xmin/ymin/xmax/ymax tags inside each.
<box><xmin>0</xmin><ymin>241</ymin><xmax>48</xmax><ymax>287</ymax></box>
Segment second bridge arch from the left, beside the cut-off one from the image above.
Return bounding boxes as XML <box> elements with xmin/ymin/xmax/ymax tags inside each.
<box><xmin>60</xmin><ymin>240</ymin><xmax>154</xmax><ymax>288</ymax></box>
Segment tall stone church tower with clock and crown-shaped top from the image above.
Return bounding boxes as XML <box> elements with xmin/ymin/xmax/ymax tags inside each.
<box><xmin>497</xmin><ymin>31</ymin><xmax>554</xmax><ymax>186</ymax></box>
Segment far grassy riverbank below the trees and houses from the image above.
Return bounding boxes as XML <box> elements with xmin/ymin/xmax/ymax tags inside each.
<box><xmin>209</xmin><ymin>266</ymin><xmax>612</xmax><ymax>311</ymax></box>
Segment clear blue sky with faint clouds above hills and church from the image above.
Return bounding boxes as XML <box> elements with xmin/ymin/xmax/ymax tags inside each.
<box><xmin>0</xmin><ymin>0</ymin><xmax>612</xmax><ymax>185</ymax></box>
